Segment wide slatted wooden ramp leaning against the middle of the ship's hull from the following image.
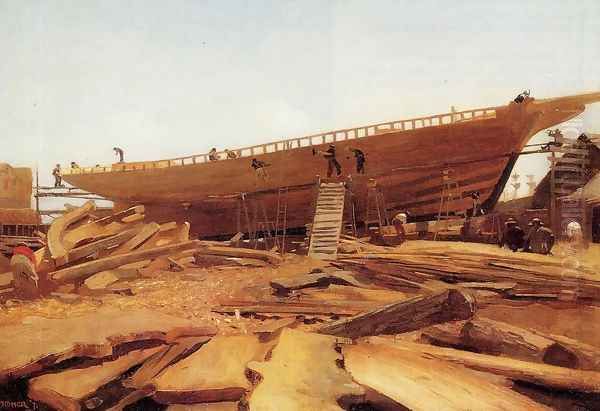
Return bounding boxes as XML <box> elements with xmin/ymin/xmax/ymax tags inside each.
<box><xmin>308</xmin><ymin>183</ymin><xmax>346</xmax><ymax>259</ymax></box>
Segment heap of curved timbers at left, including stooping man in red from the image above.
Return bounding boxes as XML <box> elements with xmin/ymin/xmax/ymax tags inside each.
<box><xmin>1</xmin><ymin>201</ymin><xmax>281</xmax><ymax>298</ymax></box>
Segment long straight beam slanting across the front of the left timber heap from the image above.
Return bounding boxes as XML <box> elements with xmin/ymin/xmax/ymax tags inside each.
<box><xmin>49</xmin><ymin>240</ymin><xmax>199</xmax><ymax>283</ymax></box>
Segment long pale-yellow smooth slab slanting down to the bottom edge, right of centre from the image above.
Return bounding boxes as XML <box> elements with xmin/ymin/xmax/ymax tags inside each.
<box><xmin>342</xmin><ymin>344</ymin><xmax>548</xmax><ymax>411</ymax></box>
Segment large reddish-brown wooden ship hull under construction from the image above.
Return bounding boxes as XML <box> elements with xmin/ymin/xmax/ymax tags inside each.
<box><xmin>63</xmin><ymin>93</ymin><xmax>600</xmax><ymax>237</ymax></box>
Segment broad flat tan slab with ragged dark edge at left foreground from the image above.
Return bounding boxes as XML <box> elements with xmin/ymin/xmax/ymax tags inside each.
<box><xmin>0</xmin><ymin>307</ymin><xmax>216</xmax><ymax>383</ymax></box>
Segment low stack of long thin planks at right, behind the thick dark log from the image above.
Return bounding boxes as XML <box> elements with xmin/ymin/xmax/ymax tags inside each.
<box><xmin>338</xmin><ymin>241</ymin><xmax>600</xmax><ymax>302</ymax></box>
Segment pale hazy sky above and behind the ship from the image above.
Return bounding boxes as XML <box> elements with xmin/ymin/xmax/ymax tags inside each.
<box><xmin>0</xmin><ymin>0</ymin><xmax>600</xmax><ymax>209</ymax></box>
